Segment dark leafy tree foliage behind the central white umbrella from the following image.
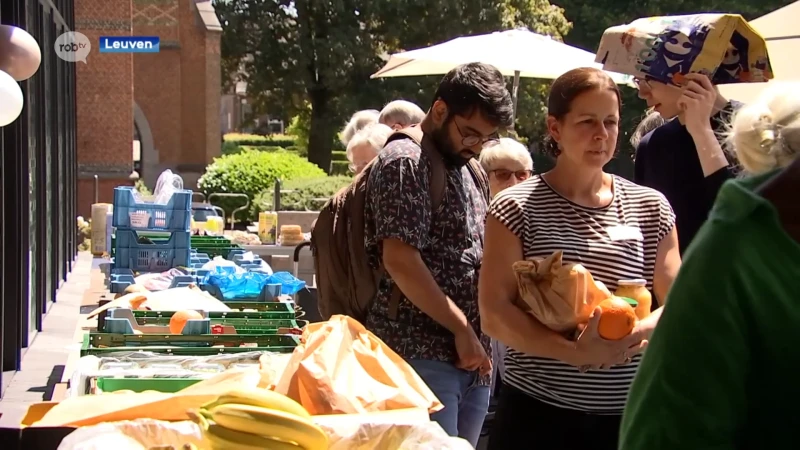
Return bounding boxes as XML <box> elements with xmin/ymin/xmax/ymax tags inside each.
<box><xmin>215</xmin><ymin>0</ymin><xmax>570</xmax><ymax>170</ymax></box>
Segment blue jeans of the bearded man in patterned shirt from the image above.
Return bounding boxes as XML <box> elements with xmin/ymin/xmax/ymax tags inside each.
<box><xmin>408</xmin><ymin>359</ymin><xmax>489</xmax><ymax>447</ymax></box>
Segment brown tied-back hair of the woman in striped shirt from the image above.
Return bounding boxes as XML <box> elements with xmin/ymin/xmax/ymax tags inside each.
<box><xmin>542</xmin><ymin>67</ymin><xmax>622</xmax><ymax>158</ymax></box>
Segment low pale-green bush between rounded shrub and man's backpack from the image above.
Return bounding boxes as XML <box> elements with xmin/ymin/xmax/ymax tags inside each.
<box><xmin>253</xmin><ymin>176</ymin><xmax>353</xmax><ymax>211</ymax></box>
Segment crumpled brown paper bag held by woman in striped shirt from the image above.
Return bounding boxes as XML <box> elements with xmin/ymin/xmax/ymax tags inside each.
<box><xmin>513</xmin><ymin>251</ymin><xmax>611</xmax><ymax>332</ymax></box>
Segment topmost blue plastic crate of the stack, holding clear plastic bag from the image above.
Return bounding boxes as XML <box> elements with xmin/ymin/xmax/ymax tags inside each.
<box><xmin>113</xmin><ymin>186</ymin><xmax>192</xmax><ymax>231</ymax></box>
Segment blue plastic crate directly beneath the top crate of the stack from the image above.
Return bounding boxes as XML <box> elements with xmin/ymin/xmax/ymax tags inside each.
<box><xmin>114</xmin><ymin>230</ymin><xmax>190</xmax><ymax>272</ymax></box>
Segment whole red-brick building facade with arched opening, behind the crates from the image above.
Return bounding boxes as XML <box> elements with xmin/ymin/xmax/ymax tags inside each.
<box><xmin>75</xmin><ymin>0</ymin><xmax>221</xmax><ymax>216</ymax></box>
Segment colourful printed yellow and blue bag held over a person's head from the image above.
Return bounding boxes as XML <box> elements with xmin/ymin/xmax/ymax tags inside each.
<box><xmin>596</xmin><ymin>14</ymin><xmax>774</xmax><ymax>85</ymax></box>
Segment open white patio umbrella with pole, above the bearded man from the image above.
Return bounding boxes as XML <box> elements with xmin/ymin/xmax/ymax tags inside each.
<box><xmin>371</xmin><ymin>29</ymin><xmax>632</xmax><ymax>123</ymax></box>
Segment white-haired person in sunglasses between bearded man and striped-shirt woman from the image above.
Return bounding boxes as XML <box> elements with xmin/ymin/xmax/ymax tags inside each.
<box><xmin>480</xmin><ymin>138</ymin><xmax>533</xmax><ymax>197</ymax></box>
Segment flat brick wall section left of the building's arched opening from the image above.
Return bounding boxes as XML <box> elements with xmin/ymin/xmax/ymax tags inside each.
<box><xmin>75</xmin><ymin>0</ymin><xmax>133</xmax><ymax>217</ymax></box>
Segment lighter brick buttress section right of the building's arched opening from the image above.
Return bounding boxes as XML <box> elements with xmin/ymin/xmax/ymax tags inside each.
<box><xmin>133</xmin><ymin>0</ymin><xmax>221</xmax><ymax>189</ymax></box>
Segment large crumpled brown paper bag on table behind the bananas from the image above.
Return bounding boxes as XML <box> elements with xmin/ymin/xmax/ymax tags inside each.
<box><xmin>275</xmin><ymin>315</ymin><xmax>444</xmax><ymax>415</ymax></box>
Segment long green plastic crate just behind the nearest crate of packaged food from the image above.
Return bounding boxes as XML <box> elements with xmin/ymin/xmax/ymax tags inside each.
<box><xmin>81</xmin><ymin>333</ymin><xmax>300</xmax><ymax>357</ymax></box>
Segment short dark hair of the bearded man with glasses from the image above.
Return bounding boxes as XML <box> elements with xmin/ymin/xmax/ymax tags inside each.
<box><xmin>433</xmin><ymin>63</ymin><xmax>514</xmax><ymax>128</ymax></box>
